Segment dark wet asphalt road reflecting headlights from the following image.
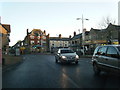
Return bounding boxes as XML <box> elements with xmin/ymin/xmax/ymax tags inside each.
<box><xmin>2</xmin><ymin>54</ymin><xmax>120</xmax><ymax>88</ymax></box>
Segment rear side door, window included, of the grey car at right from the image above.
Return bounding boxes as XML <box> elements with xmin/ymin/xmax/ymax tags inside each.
<box><xmin>106</xmin><ymin>46</ymin><xmax>119</xmax><ymax>71</ymax></box>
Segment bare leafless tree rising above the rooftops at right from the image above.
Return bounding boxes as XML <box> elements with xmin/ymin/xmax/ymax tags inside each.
<box><xmin>99</xmin><ymin>16</ymin><xmax>116</xmax><ymax>29</ymax></box>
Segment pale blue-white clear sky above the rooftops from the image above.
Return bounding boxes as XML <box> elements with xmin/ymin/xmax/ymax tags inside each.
<box><xmin>0</xmin><ymin>0</ymin><xmax>119</xmax><ymax>46</ymax></box>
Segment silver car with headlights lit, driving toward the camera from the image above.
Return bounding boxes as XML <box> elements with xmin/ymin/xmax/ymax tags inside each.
<box><xmin>55</xmin><ymin>48</ymin><xmax>79</xmax><ymax>64</ymax></box>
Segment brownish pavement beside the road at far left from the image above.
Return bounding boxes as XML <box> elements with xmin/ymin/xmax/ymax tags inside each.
<box><xmin>2</xmin><ymin>55</ymin><xmax>23</xmax><ymax>70</ymax></box>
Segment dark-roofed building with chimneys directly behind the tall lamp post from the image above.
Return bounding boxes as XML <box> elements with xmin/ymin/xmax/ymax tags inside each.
<box><xmin>69</xmin><ymin>29</ymin><xmax>91</xmax><ymax>55</ymax></box>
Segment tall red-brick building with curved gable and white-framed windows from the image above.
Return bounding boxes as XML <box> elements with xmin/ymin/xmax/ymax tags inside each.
<box><xmin>23</xmin><ymin>29</ymin><xmax>47</xmax><ymax>52</ymax></box>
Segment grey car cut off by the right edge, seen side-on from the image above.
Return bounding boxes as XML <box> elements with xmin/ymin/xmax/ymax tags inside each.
<box><xmin>92</xmin><ymin>45</ymin><xmax>120</xmax><ymax>75</ymax></box>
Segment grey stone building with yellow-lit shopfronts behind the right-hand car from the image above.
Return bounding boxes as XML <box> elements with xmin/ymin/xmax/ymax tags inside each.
<box><xmin>89</xmin><ymin>23</ymin><xmax>120</xmax><ymax>52</ymax></box>
